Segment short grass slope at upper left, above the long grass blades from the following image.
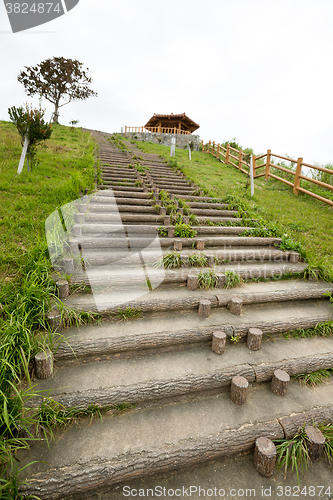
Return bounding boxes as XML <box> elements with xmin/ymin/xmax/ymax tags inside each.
<box><xmin>0</xmin><ymin>122</ymin><xmax>95</xmax><ymax>281</ymax></box>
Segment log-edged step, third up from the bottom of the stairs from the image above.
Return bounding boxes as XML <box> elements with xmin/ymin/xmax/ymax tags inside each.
<box><xmin>55</xmin><ymin>299</ymin><xmax>333</xmax><ymax>363</ymax></box>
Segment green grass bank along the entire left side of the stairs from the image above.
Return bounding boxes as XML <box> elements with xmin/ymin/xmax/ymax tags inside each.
<box><xmin>0</xmin><ymin>122</ymin><xmax>95</xmax><ymax>499</ymax></box>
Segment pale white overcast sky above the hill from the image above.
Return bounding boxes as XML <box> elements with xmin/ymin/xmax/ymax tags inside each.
<box><xmin>0</xmin><ymin>0</ymin><xmax>333</xmax><ymax>164</ymax></box>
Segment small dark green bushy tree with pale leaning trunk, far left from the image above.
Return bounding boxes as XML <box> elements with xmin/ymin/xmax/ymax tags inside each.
<box><xmin>8</xmin><ymin>104</ymin><xmax>52</xmax><ymax>171</ymax></box>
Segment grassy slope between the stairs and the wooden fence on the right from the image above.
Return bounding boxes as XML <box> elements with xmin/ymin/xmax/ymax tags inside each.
<box><xmin>128</xmin><ymin>141</ymin><xmax>333</xmax><ymax>280</ymax></box>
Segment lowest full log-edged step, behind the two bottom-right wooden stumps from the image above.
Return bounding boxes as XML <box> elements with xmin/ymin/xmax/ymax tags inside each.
<box><xmin>17</xmin><ymin>380</ymin><xmax>333</xmax><ymax>500</ymax></box>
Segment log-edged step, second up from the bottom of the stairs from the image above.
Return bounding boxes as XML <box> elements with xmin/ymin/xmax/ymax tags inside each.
<box><xmin>31</xmin><ymin>338</ymin><xmax>333</xmax><ymax>407</ymax></box>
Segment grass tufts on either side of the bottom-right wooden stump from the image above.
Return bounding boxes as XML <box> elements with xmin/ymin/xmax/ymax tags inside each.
<box><xmin>274</xmin><ymin>423</ymin><xmax>333</xmax><ymax>486</ymax></box>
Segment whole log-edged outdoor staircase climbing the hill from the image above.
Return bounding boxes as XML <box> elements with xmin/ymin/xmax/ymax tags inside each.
<box><xmin>18</xmin><ymin>132</ymin><xmax>333</xmax><ymax>499</ymax></box>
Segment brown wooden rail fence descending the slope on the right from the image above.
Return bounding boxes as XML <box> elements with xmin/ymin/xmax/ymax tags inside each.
<box><xmin>201</xmin><ymin>141</ymin><xmax>333</xmax><ymax>206</ymax></box>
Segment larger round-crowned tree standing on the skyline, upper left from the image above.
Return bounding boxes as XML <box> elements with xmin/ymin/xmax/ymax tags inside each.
<box><xmin>17</xmin><ymin>57</ymin><xmax>97</xmax><ymax>123</ymax></box>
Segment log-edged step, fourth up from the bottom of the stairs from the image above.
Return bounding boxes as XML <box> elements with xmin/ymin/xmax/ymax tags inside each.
<box><xmin>59</xmin><ymin>279</ymin><xmax>333</xmax><ymax>314</ymax></box>
